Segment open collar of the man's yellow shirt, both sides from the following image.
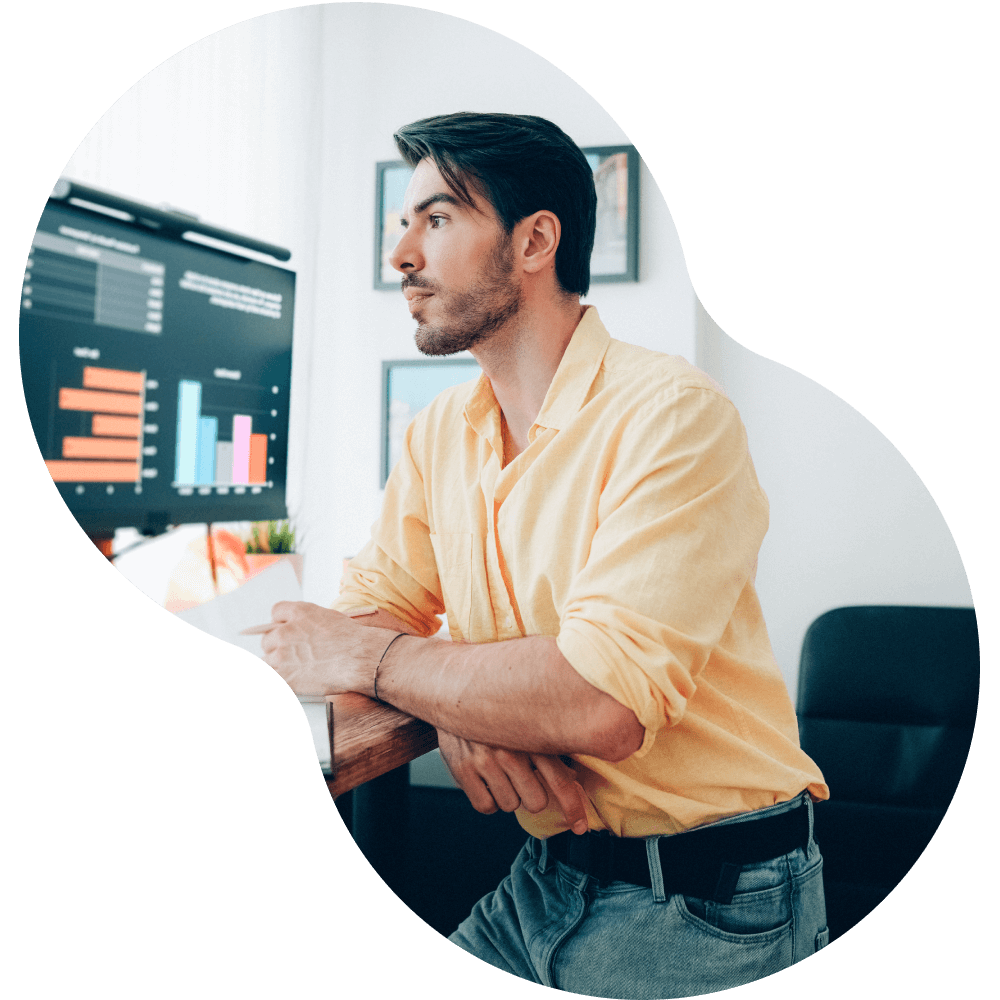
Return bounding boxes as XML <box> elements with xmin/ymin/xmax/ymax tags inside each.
<box><xmin>465</xmin><ymin>306</ymin><xmax>611</xmax><ymax>436</ymax></box>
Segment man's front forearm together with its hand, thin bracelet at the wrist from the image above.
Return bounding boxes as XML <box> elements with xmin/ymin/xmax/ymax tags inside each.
<box><xmin>270</xmin><ymin>601</ymin><xmax>644</xmax><ymax>761</ymax></box>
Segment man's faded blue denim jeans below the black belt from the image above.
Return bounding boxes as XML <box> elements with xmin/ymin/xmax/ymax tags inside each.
<box><xmin>449</xmin><ymin>792</ymin><xmax>829</xmax><ymax>1000</ymax></box>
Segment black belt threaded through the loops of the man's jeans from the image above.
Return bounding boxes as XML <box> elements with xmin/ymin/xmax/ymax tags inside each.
<box><xmin>545</xmin><ymin>803</ymin><xmax>809</xmax><ymax>903</ymax></box>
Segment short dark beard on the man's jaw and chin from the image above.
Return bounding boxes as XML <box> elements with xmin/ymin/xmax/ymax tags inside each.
<box><xmin>403</xmin><ymin>234</ymin><xmax>521</xmax><ymax>356</ymax></box>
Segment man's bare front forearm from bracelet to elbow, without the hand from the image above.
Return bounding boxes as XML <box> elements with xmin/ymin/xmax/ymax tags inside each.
<box><xmin>372</xmin><ymin>628</ymin><xmax>643</xmax><ymax>760</ymax></box>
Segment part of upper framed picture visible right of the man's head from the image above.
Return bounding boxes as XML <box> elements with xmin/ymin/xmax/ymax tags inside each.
<box><xmin>583</xmin><ymin>146</ymin><xmax>639</xmax><ymax>283</ymax></box>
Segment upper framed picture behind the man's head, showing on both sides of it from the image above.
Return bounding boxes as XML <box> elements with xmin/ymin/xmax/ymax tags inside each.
<box><xmin>375</xmin><ymin>146</ymin><xmax>639</xmax><ymax>292</ymax></box>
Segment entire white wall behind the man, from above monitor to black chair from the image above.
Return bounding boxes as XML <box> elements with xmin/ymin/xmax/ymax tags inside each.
<box><xmin>43</xmin><ymin>3</ymin><xmax>972</xmax><ymax>704</ymax></box>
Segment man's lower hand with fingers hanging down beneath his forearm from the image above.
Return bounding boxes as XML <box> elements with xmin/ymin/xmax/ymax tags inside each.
<box><xmin>438</xmin><ymin>729</ymin><xmax>587</xmax><ymax>833</ymax></box>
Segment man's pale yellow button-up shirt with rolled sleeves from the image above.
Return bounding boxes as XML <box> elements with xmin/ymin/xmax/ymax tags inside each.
<box><xmin>333</xmin><ymin>307</ymin><xmax>829</xmax><ymax>838</ymax></box>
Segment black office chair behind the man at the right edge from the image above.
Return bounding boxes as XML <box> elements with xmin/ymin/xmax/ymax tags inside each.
<box><xmin>797</xmin><ymin>606</ymin><xmax>979</xmax><ymax>941</ymax></box>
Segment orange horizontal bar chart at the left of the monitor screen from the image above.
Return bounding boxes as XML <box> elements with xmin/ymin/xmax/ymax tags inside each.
<box><xmin>45</xmin><ymin>365</ymin><xmax>146</xmax><ymax>483</ymax></box>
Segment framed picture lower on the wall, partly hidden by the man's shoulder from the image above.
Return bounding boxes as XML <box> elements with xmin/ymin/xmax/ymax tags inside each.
<box><xmin>379</xmin><ymin>357</ymin><xmax>482</xmax><ymax>489</ymax></box>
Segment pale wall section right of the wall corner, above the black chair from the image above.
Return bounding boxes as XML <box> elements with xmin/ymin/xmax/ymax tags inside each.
<box><xmin>696</xmin><ymin>302</ymin><xmax>973</xmax><ymax>694</ymax></box>
